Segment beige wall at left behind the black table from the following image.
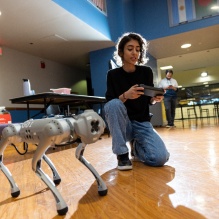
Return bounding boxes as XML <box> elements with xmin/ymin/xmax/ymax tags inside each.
<box><xmin>0</xmin><ymin>47</ymin><xmax>87</xmax><ymax>107</ymax></box>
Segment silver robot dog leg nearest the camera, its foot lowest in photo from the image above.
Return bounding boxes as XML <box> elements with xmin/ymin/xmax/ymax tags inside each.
<box><xmin>32</xmin><ymin>138</ymin><xmax>68</xmax><ymax>215</ymax></box>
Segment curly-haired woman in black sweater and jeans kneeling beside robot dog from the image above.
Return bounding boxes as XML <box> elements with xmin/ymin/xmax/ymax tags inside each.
<box><xmin>104</xmin><ymin>33</ymin><xmax>169</xmax><ymax>170</ymax></box>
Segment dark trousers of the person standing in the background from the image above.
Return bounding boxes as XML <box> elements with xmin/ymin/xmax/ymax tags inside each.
<box><xmin>164</xmin><ymin>97</ymin><xmax>176</xmax><ymax>125</ymax></box>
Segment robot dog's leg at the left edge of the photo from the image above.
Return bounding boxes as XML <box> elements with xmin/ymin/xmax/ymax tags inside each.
<box><xmin>0</xmin><ymin>138</ymin><xmax>20</xmax><ymax>197</ymax></box>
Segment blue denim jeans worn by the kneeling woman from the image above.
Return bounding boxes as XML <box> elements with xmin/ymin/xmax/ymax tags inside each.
<box><xmin>104</xmin><ymin>99</ymin><xmax>169</xmax><ymax>166</ymax></box>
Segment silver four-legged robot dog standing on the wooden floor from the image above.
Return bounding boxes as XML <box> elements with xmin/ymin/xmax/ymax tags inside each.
<box><xmin>0</xmin><ymin>110</ymin><xmax>107</xmax><ymax>215</ymax></box>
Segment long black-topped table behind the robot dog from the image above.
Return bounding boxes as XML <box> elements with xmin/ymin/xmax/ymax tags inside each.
<box><xmin>10</xmin><ymin>92</ymin><xmax>106</xmax><ymax>119</ymax></box>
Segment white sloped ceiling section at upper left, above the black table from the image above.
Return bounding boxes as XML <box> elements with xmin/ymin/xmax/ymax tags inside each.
<box><xmin>0</xmin><ymin>0</ymin><xmax>114</xmax><ymax>70</ymax></box>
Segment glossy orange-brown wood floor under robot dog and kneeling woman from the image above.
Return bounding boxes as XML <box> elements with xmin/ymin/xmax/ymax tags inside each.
<box><xmin>0</xmin><ymin>118</ymin><xmax>219</xmax><ymax>219</ymax></box>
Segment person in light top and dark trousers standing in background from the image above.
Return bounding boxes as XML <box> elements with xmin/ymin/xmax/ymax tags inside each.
<box><xmin>158</xmin><ymin>70</ymin><xmax>178</xmax><ymax>128</ymax></box>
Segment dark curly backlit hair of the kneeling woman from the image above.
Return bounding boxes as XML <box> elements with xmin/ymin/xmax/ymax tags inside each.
<box><xmin>113</xmin><ymin>32</ymin><xmax>148</xmax><ymax>66</ymax></box>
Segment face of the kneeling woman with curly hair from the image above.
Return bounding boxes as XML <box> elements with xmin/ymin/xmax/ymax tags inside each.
<box><xmin>121</xmin><ymin>39</ymin><xmax>140</xmax><ymax>65</ymax></box>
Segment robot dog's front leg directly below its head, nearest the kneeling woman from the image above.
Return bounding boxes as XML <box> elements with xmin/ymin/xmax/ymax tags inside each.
<box><xmin>75</xmin><ymin>143</ymin><xmax>107</xmax><ymax>196</ymax></box>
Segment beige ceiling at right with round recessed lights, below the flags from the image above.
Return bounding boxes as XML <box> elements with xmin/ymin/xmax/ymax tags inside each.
<box><xmin>148</xmin><ymin>25</ymin><xmax>219</xmax><ymax>87</ymax></box>
